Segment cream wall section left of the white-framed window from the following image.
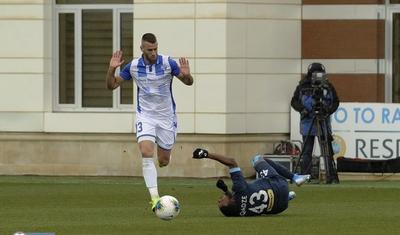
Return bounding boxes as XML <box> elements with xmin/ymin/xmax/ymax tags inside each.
<box><xmin>0</xmin><ymin>0</ymin><xmax>51</xmax><ymax>132</ymax></box>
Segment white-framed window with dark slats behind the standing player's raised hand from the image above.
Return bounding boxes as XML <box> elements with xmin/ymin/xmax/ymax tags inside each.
<box><xmin>54</xmin><ymin>0</ymin><xmax>133</xmax><ymax>111</ymax></box>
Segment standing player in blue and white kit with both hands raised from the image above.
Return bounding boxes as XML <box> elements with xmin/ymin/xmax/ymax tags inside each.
<box><xmin>107</xmin><ymin>33</ymin><xmax>193</xmax><ymax>211</ymax></box>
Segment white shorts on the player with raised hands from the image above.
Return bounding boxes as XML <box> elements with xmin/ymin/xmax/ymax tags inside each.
<box><xmin>135</xmin><ymin>114</ymin><xmax>178</xmax><ymax>150</ymax></box>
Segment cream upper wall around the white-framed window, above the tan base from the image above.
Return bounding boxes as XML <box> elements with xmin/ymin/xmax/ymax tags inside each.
<box><xmin>0</xmin><ymin>0</ymin><xmax>301</xmax><ymax>134</ymax></box>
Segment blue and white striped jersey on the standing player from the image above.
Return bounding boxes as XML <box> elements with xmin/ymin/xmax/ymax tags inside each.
<box><xmin>120</xmin><ymin>54</ymin><xmax>180</xmax><ymax>118</ymax></box>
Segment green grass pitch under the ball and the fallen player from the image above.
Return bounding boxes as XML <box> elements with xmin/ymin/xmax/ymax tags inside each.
<box><xmin>0</xmin><ymin>176</ymin><xmax>400</xmax><ymax>235</ymax></box>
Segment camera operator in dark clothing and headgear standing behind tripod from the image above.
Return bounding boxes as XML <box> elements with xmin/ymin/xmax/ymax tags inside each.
<box><xmin>291</xmin><ymin>63</ymin><xmax>339</xmax><ymax>183</ymax></box>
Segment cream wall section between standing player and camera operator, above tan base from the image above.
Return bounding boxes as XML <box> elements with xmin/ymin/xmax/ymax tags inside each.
<box><xmin>134</xmin><ymin>0</ymin><xmax>301</xmax><ymax>134</ymax></box>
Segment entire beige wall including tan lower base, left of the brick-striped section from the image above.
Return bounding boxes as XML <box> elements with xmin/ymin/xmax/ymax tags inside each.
<box><xmin>0</xmin><ymin>0</ymin><xmax>301</xmax><ymax>177</ymax></box>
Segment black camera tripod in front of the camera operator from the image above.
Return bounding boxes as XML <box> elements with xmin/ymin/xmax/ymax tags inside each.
<box><xmin>295</xmin><ymin>112</ymin><xmax>339</xmax><ymax>184</ymax></box>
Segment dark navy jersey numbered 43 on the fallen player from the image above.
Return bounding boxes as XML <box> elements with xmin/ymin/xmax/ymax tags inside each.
<box><xmin>230</xmin><ymin>168</ymin><xmax>289</xmax><ymax>216</ymax></box>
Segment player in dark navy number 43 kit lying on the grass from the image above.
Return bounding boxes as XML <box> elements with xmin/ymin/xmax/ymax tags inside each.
<box><xmin>193</xmin><ymin>148</ymin><xmax>310</xmax><ymax>216</ymax></box>
